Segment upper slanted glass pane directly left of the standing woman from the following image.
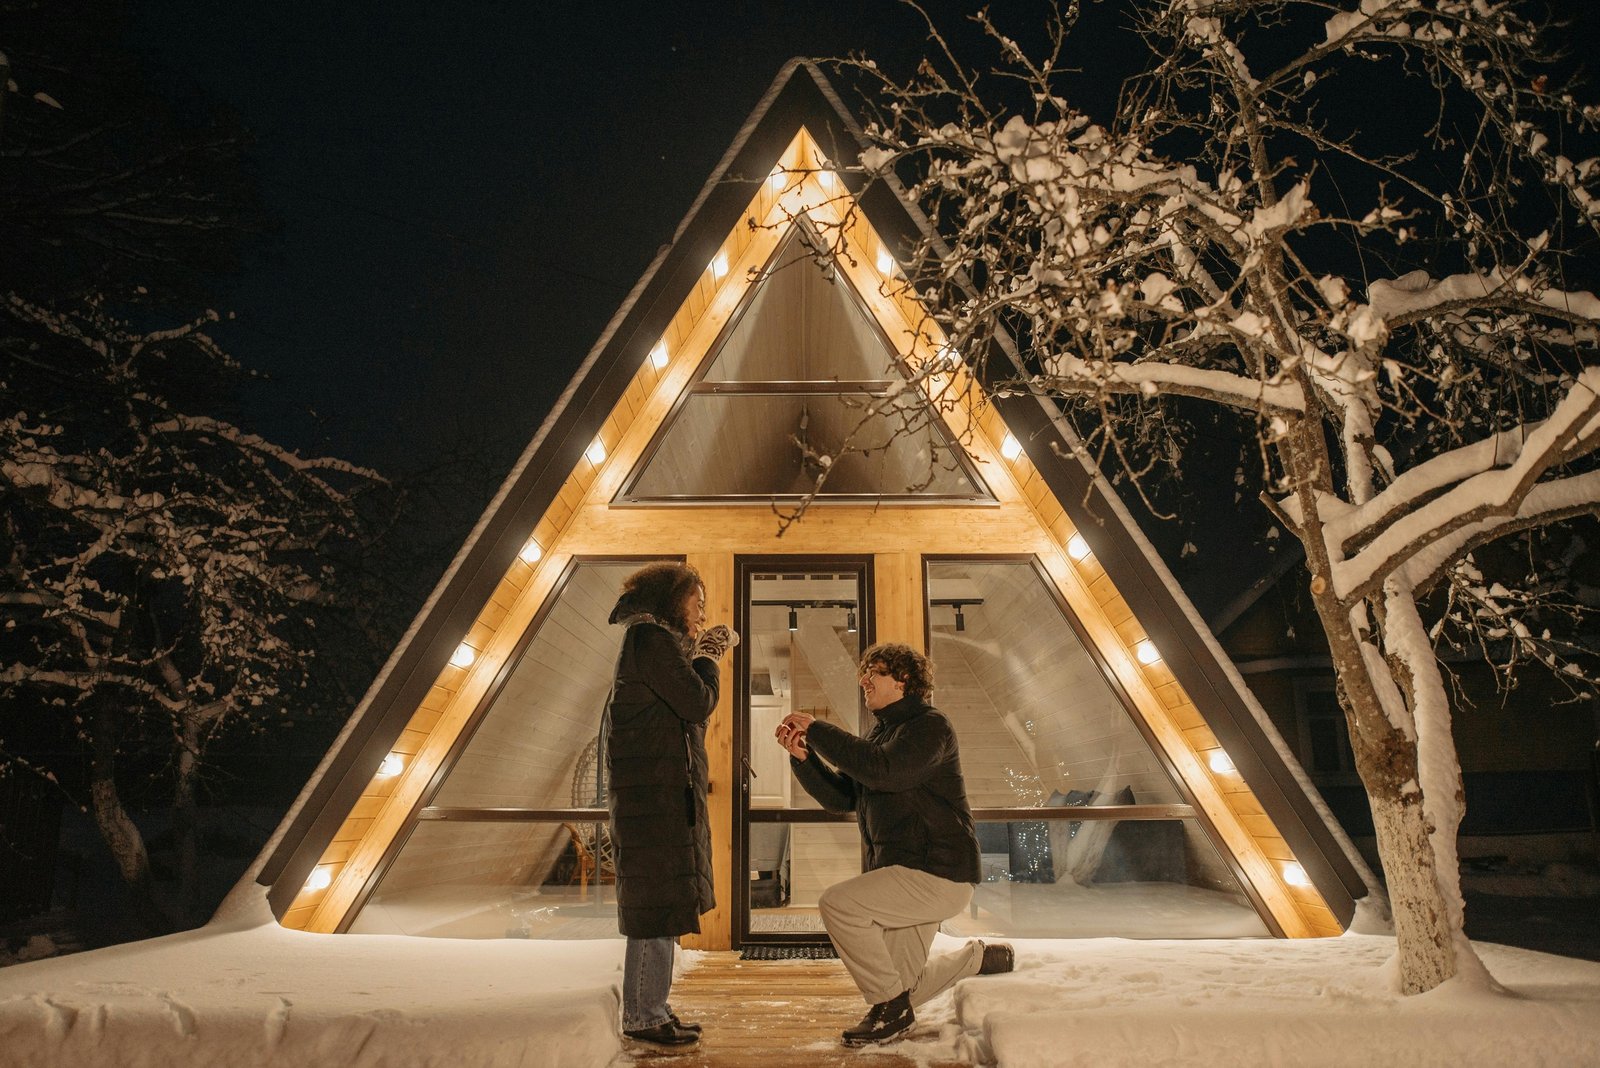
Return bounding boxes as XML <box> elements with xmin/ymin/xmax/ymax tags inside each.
<box><xmin>432</xmin><ymin>563</ymin><xmax>640</xmax><ymax>809</ymax></box>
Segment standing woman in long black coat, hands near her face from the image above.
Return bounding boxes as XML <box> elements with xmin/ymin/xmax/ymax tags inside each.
<box><xmin>603</xmin><ymin>563</ymin><xmax>739</xmax><ymax>1046</ymax></box>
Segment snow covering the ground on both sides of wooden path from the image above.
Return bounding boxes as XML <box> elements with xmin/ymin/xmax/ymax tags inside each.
<box><xmin>0</xmin><ymin>921</ymin><xmax>1600</xmax><ymax>1068</ymax></box>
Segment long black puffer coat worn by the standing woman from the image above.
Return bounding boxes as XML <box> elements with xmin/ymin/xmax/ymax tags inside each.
<box><xmin>605</xmin><ymin>604</ymin><xmax>718</xmax><ymax>938</ymax></box>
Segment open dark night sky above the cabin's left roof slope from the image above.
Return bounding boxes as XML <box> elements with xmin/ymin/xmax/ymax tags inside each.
<box><xmin>124</xmin><ymin>0</ymin><xmax>1068</xmax><ymax>481</ymax></box>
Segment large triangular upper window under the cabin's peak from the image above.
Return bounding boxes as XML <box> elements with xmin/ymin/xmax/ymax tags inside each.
<box><xmin>618</xmin><ymin>217</ymin><xmax>992</xmax><ymax>502</ymax></box>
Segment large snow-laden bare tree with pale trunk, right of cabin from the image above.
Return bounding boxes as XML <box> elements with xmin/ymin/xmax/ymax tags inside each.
<box><xmin>854</xmin><ymin>0</ymin><xmax>1600</xmax><ymax>993</ymax></box>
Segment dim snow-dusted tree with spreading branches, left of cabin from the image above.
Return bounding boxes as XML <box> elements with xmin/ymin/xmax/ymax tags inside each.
<box><xmin>0</xmin><ymin>294</ymin><xmax>376</xmax><ymax>927</ymax></box>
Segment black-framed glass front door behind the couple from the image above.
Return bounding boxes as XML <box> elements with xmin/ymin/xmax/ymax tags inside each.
<box><xmin>733</xmin><ymin>556</ymin><xmax>872</xmax><ymax>945</ymax></box>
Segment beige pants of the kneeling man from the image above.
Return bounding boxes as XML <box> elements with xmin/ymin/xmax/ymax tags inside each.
<box><xmin>818</xmin><ymin>865</ymin><xmax>984</xmax><ymax>1006</ymax></box>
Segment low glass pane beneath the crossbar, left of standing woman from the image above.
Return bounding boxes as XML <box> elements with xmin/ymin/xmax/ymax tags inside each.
<box><xmin>350</xmin><ymin>820</ymin><xmax>621</xmax><ymax>938</ymax></box>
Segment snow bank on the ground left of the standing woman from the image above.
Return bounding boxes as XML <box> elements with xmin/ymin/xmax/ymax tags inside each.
<box><xmin>0</xmin><ymin>895</ymin><xmax>622</xmax><ymax>1068</ymax></box>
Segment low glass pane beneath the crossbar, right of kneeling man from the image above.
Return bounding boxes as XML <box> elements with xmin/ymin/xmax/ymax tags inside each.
<box><xmin>944</xmin><ymin>819</ymin><xmax>1270</xmax><ymax>938</ymax></box>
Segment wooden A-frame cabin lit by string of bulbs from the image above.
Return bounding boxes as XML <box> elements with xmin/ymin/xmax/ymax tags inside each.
<box><xmin>256</xmin><ymin>61</ymin><xmax>1366</xmax><ymax>948</ymax></box>
